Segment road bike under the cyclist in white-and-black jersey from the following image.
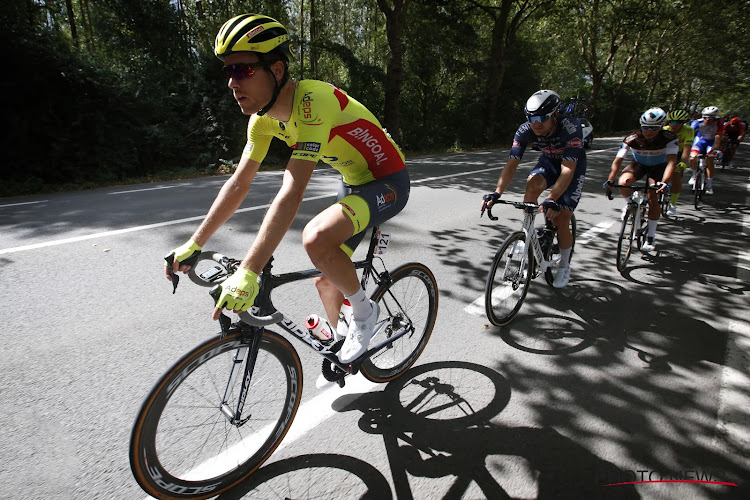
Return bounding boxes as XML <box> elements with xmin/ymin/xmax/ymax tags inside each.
<box><xmin>604</xmin><ymin>183</ymin><xmax>669</xmax><ymax>272</ymax></box>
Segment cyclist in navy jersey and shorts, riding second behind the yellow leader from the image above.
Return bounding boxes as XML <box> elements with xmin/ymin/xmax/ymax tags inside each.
<box><xmin>484</xmin><ymin>90</ymin><xmax>586</xmax><ymax>288</ymax></box>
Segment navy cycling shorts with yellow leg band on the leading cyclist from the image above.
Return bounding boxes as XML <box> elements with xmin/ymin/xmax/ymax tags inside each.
<box><xmin>336</xmin><ymin>169</ymin><xmax>410</xmax><ymax>257</ymax></box>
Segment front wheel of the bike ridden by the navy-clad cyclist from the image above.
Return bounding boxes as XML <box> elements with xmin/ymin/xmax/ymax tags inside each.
<box><xmin>484</xmin><ymin>231</ymin><xmax>534</xmax><ymax>326</ymax></box>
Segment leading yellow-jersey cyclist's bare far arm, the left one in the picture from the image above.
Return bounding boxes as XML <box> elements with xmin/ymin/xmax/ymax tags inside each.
<box><xmin>193</xmin><ymin>156</ymin><xmax>260</xmax><ymax>247</ymax></box>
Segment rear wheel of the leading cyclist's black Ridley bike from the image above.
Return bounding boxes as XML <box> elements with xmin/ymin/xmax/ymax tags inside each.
<box><xmin>360</xmin><ymin>262</ymin><xmax>438</xmax><ymax>383</ymax></box>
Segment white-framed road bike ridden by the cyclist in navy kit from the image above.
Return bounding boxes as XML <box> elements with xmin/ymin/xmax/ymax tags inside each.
<box><xmin>480</xmin><ymin>200</ymin><xmax>576</xmax><ymax>326</ymax></box>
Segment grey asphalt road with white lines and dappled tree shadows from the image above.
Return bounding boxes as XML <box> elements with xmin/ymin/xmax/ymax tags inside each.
<box><xmin>0</xmin><ymin>139</ymin><xmax>750</xmax><ymax>499</ymax></box>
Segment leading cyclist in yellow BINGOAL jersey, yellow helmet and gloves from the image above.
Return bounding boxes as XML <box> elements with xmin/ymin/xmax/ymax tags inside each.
<box><xmin>167</xmin><ymin>14</ymin><xmax>409</xmax><ymax>363</ymax></box>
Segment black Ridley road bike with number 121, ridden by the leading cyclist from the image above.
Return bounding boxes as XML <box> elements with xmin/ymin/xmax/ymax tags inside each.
<box><xmin>130</xmin><ymin>227</ymin><xmax>438</xmax><ymax>499</ymax></box>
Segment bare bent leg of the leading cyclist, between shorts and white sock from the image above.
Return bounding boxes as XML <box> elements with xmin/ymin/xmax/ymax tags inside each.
<box><xmin>302</xmin><ymin>204</ymin><xmax>360</xmax><ymax>322</ymax></box>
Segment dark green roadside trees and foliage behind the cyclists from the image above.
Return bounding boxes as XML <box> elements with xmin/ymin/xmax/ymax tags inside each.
<box><xmin>0</xmin><ymin>0</ymin><xmax>750</xmax><ymax>196</ymax></box>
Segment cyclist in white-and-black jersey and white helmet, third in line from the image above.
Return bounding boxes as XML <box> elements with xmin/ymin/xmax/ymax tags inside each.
<box><xmin>604</xmin><ymin>108</ymin><xmax>679</xmax><ymax>253</ymax></box>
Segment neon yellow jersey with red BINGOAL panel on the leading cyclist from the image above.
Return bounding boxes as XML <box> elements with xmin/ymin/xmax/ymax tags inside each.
<box><xmin>243</xmin><ymin>80</ymin><xmax>406</xmax><ymax>186</ymax></box>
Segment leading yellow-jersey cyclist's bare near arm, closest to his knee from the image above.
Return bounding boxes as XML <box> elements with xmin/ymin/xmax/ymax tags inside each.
<box><xmin>241</xmin><ymin>158</ymin><xmax>316</xmax><ymax>274</ymax></box>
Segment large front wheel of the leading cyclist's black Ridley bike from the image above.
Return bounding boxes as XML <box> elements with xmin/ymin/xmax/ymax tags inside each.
<box><xmin>130</xmin><ymin>331</ymin><xmax>302</xmax><ymax>499</ymax></box>
